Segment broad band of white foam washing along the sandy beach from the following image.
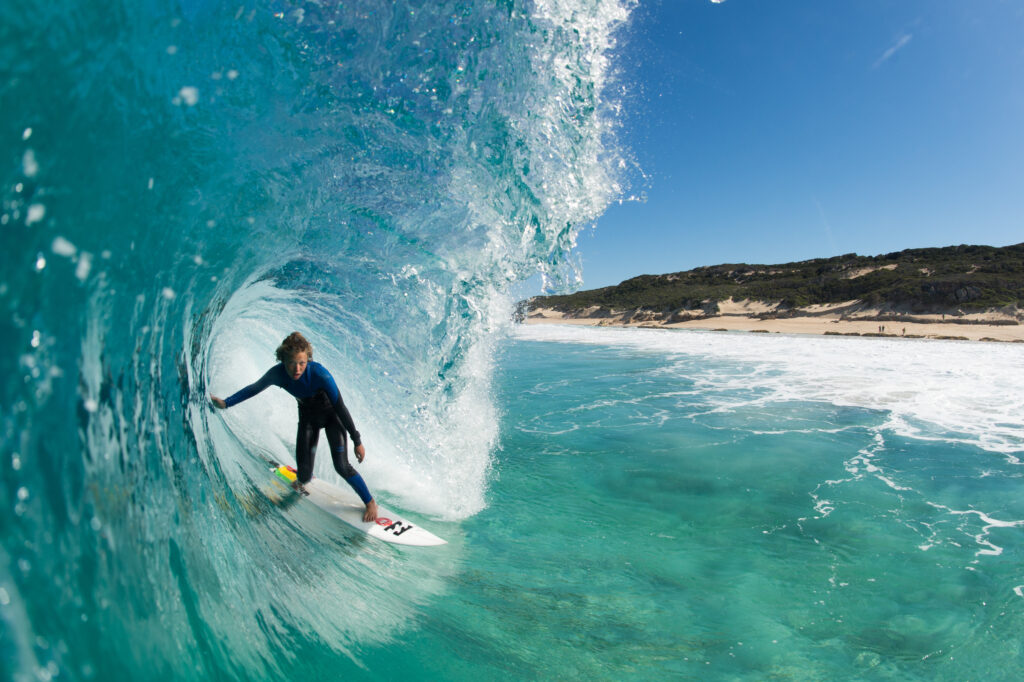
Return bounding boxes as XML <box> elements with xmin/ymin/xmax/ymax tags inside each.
<box><xmin>516</xmin><ymin>325</ymin><xmax>1024</xmax><ymax>454</ymax></box>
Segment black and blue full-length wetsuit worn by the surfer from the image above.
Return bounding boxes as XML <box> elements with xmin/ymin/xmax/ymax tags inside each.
<box><xmin>224</xmin><ymin>360</ymin><xmax>373</xmax><ymax>503</ymax></box>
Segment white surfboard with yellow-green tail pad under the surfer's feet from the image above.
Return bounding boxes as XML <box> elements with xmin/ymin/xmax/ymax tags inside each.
<box><xmin>270</xmin><ymin>466</ymin><xmax>447</xmax><ymax>547</ymax></box>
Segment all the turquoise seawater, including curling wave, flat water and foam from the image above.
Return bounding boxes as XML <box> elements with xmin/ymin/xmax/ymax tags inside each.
<box><xmin>0</xmin><ymin>0</ymin><xmax>1024</xmax><ymax>681</ymax></box>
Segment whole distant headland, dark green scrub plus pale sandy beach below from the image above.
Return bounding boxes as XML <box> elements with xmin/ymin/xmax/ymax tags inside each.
<box><xmin>519</xmin><ymin>244</ymin><xmax>1024</xmax><ymax>342</ymax></box>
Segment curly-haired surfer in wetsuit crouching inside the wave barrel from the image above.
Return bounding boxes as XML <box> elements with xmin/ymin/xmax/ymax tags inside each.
<box><xmin>210</xmin><ymin>332</ymin><xmax>377</xmax><ymax>521</ymax></box>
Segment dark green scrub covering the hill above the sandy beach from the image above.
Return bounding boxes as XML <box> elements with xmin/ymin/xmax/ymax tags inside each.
<box><xmin>525</xmin><ymin>244</ymin><xmax>1024</xmax><ymax>315</ymax></box>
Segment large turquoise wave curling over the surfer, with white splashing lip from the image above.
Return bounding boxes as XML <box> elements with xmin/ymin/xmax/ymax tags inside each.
<box><xmin>0</xmin><ymin>0</ymin><xmax>628</xmax><ymax>679</ymax></box>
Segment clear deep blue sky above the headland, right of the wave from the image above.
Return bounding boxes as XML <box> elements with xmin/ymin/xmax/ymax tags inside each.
<box><xmin>578</xmin><ymin>0</ymin><xmax>1024</xmax><ymax>289</ymax></box>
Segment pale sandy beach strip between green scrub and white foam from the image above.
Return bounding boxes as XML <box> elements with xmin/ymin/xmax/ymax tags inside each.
<box><xmin>525</xmin><ymin>300</ymin><xmax>1024</xmax><ymax>343</ymax></box>
